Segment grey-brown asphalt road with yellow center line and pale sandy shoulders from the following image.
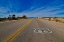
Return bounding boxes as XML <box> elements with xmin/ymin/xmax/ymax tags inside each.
<box><xmin>0</xmin><ymin>19</ymin><xmax>64</xmax><ymax>42</ymax></box>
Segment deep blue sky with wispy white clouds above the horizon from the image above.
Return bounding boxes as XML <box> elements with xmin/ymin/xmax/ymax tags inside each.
<box><xmin>0</xmin><ymin>0</ymin><xmax>64</xmax><ymax>17</ymax></box>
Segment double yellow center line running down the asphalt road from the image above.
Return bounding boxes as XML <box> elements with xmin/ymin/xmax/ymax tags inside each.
<box><xmin>4</xmin><ymin>19</ymin><xmax>33</xmax><ymax>42</ymax></box>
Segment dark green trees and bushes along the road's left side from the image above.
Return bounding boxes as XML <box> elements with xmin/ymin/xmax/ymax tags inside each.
<box><xmin>0</xmin><ymin>14</ymin><xmax>27</xmax><ymax>22</ymax></box>
